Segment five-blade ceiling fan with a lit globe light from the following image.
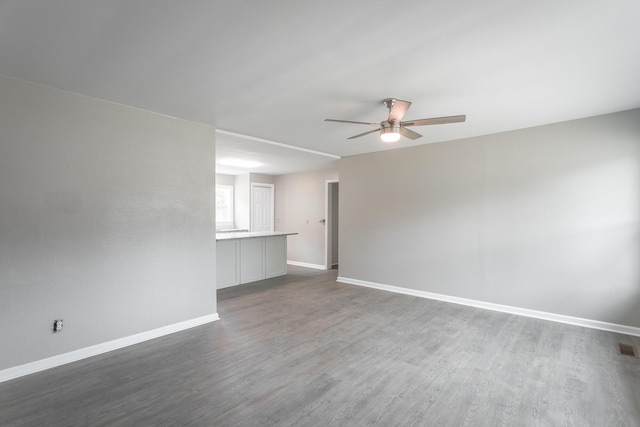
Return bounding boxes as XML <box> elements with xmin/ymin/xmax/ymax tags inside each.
<box><xmin>324</xmin><ymin>98</ymin><xmax>467</xmax><ymax>142</ymax></box>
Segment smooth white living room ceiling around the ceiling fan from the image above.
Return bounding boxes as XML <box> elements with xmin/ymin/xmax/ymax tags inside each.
<box><xmin>0</xmin><ymin>0</ymin><xmax>640</xmax><ymax>173</ymax></box>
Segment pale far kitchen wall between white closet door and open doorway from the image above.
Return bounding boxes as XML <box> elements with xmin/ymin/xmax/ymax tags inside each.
<box><xmin>275</xmin><ymin>169</ymin><xmax>338</xmax><ymax>268</ymax></box>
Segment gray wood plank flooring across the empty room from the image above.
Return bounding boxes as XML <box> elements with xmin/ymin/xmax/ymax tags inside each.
<box><xmin>0</xmin><ymin>266</ymin><xmax>640</xmax><ymax>427</ymax></box>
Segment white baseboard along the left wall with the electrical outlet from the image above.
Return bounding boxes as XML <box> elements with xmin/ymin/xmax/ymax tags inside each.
<box><xmin>0</xmin><ymin>313</ymin><xmax>220</xmax><ymax>383</ymax></box>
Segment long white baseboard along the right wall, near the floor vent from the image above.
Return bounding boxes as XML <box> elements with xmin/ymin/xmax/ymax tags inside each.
<box><xmin>337</xmin><ymin>277</ymin><xmax>640</xmax><ymax>337</ymax></box>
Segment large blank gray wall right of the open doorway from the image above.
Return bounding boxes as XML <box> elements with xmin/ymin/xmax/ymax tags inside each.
<box><xmin>340</xmin><ymin>110</ymin><xmax>640</xmax><ymax>327</ymax></box>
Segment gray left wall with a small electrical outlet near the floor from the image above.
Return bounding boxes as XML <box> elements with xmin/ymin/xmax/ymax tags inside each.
<box><xmin>0</xmin><ymin>76</ymin><xmax>216</xmax><ymax>370</ymax></box>
